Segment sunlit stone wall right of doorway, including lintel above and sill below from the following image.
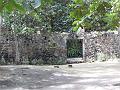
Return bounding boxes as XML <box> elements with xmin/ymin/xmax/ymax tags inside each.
<box><xmin>64</xmin><ymin>31</ymin><xmax>120</xmax><ymax>62</ymax></box>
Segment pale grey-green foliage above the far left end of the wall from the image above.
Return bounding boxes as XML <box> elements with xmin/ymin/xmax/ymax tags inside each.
<box><xmin>1</xmin><ymin>11</ymin><xmax>36</xmax><ymax>34</ymax></box>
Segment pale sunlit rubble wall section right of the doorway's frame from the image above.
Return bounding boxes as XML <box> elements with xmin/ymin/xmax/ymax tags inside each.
<box><xmin>85</xmin><ymin>33</ymin><xmax>120</xmax><ymax>61</ymax></box>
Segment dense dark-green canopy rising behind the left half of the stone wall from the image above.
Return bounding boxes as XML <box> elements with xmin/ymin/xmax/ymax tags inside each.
<box><xmin>1</xmin><ymin>0</ymin><xmax>73</xmax><ymax>34</ymax></box>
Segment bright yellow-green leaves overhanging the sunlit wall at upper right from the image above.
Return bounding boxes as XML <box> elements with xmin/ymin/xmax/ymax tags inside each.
<box><xmin>70</xmin><ymin>0</ymin><xmax>120</xmax><ymax>31</ymax></box>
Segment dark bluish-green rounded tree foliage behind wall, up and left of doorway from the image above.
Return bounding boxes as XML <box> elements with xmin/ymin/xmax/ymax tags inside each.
<box><xmin>40</xmin><ymin>0</ymin><xmax>72</xmax><ymax>32</ymax></box>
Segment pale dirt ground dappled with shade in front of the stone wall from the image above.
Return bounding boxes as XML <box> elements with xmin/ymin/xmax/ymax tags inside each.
<box><xmin>0</xmin><ymin>63</ymin><xmax>120</xmax><ymax>90</ymax></box>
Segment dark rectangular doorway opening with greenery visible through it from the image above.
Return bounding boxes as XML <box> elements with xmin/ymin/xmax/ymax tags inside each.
<box><xmin>67</xmin><ymin>39</ymin><xmax>83</xmax><ymax>58</ymax></box>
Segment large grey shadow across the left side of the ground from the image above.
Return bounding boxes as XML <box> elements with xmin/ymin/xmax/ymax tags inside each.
<box><xmin>0</xmin><ymin>68</ymin><xmax>80</xmax><ymax>90</ymax></box>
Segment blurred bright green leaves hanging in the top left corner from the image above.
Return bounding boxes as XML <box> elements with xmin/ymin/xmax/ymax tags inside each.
<box><xmin>0</xmin><ymin>0</ymin><xmax>52</xmax><ymax>13</ymax></box>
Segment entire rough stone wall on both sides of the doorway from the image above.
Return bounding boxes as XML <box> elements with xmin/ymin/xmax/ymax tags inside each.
<box><xmin>0</xmin><ymin>27</ymin><xmax>119</xmax><ymax>64</ymax></box>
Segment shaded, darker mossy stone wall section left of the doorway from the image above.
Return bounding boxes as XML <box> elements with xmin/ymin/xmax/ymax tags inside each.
<box><xmin>0</xmin><ymin>28</ymin><xmax>67</xmax><ymax>65</ymax></box>
